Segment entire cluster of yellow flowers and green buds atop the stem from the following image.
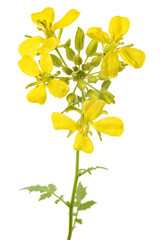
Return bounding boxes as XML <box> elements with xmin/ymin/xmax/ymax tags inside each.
<box><xmin>18</xmin><ymin>7</ymin><xmax>145</xmax><ymax>153</ymax></box>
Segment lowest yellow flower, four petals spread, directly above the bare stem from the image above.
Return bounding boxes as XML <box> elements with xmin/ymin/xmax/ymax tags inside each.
<box><xmin>52</xmin><ymin>99</ymin><xmax>124</xmax><ymax>153</ymax></box>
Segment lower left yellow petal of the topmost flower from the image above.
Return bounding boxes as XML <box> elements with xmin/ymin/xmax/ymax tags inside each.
<box><xmin>18</xmin><ymin>36</ymin><xmax>43</xmax><ymax>57</ymax></box>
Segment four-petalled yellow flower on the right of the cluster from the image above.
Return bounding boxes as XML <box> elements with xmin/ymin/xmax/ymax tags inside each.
<box><xmin>86</xmin><ymin>16</ymin><xmax>145</xmax><ymax>78</ymax></box>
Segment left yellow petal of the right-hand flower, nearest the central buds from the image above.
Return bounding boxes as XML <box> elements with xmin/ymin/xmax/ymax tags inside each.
<box><xmin>86</xmin><ymin>27</ymin><xmax>110</xmax><ymax>43</ymax></box>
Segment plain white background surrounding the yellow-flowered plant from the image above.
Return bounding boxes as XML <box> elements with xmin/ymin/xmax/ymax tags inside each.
<box><xmin>0</xmin><ymin>0</ymin><xmax>160</xmax><ymax>240</ymax></box>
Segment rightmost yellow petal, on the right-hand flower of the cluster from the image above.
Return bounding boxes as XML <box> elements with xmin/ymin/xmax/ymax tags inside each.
<box><xmin>118</xmin><ymin>48</ymin><xmax>145</xmax><ymax>68</ymax></box>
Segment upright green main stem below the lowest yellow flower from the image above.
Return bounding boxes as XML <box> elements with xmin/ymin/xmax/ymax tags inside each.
<box><xmin>67</xmin><ymin>151</ymin><xmax>79</xmax><ymax>240</ymax></box>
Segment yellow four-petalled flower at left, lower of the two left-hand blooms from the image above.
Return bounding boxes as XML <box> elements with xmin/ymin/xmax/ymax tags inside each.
<box><xmin>18</xmin><ymin>54</ymin><xmax>69</xmax><ymax>105</ymax></box>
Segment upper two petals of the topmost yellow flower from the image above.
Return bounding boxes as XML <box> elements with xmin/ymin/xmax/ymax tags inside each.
<box><xmin>31</xmin><ymin>7</ymin><xmax>80</xmax><ymax>30</ymax></box>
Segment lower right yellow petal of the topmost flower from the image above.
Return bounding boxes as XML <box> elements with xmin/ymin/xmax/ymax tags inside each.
<box><xmin>38</xmin><ymin>37</ymin><xmax>60</xmax><ymax>54</ymax></box>
